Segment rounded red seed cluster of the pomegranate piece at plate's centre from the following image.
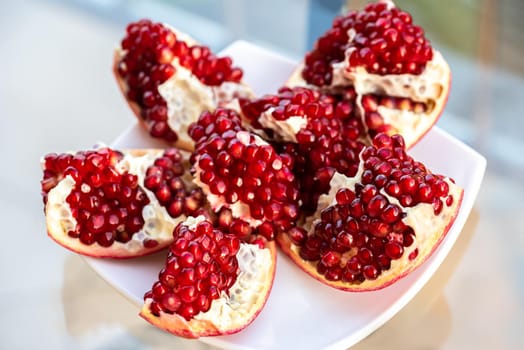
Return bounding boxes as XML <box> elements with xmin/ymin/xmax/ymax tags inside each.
<box><xmin>198</xmin><ymin>131</ymin><xmax>299</xmax><ymax>229</ymax></box>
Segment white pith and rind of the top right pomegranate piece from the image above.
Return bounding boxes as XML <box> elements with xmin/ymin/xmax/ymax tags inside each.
<box><xmin>286</xmin><ymin>1</ymin><xmax>451</xmax><ymax>148</ymax></box>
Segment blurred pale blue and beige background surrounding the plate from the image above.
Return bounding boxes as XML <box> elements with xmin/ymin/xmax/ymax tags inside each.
<box><xmin>0</xmin><ymin>0</ymin><xmax>524</xmax><ymax>349</ymax></box>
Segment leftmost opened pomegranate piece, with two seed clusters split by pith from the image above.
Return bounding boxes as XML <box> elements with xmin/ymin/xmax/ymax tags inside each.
<box><xmin>41</xmin><ymin>147</ymin><xmax>205</xmax><ymax>258</ymax></box>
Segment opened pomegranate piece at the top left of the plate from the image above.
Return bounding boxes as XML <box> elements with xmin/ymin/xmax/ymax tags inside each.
<box><xmin>114</xmin><ymin>19</ymin><xmax>252</xmax><ymax>150</ymax></box>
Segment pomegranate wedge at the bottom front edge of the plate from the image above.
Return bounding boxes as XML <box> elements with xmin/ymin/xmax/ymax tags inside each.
<box><xmin>140</xmin><ymin>216</ymin><xmax>276</xmax><ymax>338</ymax></box>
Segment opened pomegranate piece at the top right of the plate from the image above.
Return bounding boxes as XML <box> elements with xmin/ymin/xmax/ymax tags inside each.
<box><xmin>288</xmin><ymin>0</ymin><xmax>451</xmax><ymax>148</ymax></box>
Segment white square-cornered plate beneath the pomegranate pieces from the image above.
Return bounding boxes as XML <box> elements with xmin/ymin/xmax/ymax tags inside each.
<box><xmin>86</xmin><ymin>41</ymin><xmax>486</xmax><ymax>350</ymax></box>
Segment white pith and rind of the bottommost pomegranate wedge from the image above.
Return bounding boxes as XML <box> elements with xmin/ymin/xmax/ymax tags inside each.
<box><xmin>141</xmin><ymin>215</ymin><xmax>274</xmax><ymax>338</ymax></box>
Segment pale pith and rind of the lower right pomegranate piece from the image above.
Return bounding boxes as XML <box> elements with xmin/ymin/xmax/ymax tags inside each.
<box><xmin>284</xmin><ymin>150</ymin><xmax>463</xmax><ymax>291</ymax></box>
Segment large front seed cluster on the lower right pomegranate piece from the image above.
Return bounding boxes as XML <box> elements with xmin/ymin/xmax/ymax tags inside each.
<box><xmin>292</xmin><ymin>185</ymin><xmax>415</xmax><ymax>282</ymax></box>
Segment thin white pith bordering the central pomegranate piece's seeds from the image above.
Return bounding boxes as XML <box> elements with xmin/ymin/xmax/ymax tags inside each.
<box><xmin>193</xmin><ymin>131</ymin><xmax>269</xmax><ymax>228</ymax></box>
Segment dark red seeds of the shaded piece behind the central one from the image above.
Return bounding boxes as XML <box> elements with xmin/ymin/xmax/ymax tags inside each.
<box><xmin>241</xmin><ymin>87</ymin><xmax>363</xmax><ymax>212</ymax></box>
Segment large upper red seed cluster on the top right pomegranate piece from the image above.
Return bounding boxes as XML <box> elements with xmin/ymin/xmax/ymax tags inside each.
<box><xmin>302</xmin><ymin>2</ymin><xmax>433</xmax><ymax>86</ymax></box>
